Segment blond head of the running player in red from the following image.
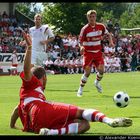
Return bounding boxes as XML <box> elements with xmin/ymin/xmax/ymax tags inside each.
<box><xmin>87</xmin><ymin>10</ymin><xmax>97</xmax><ymax>24</ymax></box>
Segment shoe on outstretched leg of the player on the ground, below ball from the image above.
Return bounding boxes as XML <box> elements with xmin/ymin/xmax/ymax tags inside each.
<box><xmin>109</xmin><ymin>118</ymin><xmax>132</xmax><ymax>127</ymax></box>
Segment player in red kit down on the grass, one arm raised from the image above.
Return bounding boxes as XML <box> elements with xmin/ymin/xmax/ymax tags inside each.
<box><xmin>10</xmin><ymin>32</ymin><xmax>132</xmax><ymax>135</ymax></box>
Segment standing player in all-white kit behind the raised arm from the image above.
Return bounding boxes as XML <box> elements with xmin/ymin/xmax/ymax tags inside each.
<box><xmin>29</xmin><ymin>14</ymin><xmax>54</xmax><ymax>65</ymax></box>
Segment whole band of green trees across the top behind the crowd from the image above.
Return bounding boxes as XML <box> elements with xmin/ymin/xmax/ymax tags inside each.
<box><xmin>17</xmin><ymin>2</ymin><xmax>140</xmax><ymax>35</ymax></box>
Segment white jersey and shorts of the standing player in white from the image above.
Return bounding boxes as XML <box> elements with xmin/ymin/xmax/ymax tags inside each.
<box><xmin>29</xmin><ymin>25</ymin><xmax>54</xmax><ymax>65</ymax></box>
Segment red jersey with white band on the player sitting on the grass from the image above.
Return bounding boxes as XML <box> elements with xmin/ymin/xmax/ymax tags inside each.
<box><xmin>18</xmin><ymin>72</ymin><xmax>46</xmax><ymax>131</ymax></box>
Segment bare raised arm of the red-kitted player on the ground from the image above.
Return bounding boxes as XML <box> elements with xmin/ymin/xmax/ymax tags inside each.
<box><xmin>22</xmin><ymin>32</ymin><xmax>32</xmax><ymax>80</ymax></box>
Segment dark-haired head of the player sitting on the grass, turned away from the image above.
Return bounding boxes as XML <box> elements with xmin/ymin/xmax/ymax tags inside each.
<box><xmin>31</xmin><ymin>66</ymin><xmax>47</xmax><ymax>89</ymax></box>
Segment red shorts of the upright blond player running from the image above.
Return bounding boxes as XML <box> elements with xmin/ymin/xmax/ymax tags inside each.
<box><xmin>83</xmin><ymin>51</ymin><xmax>104</xmax><ymax>68</ymax></box>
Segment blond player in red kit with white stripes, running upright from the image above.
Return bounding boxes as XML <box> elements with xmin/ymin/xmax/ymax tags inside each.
<box><xmin>77</xmin><ymin>10</ymin><xmax>114</xmax><ymax>97</ymax></box>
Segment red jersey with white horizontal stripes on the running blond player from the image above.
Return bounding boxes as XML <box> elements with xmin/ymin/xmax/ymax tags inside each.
<box><xmin>79</xmin><ymin>23</ymin><xmax>108</xmax><ymax>52</ymax></box>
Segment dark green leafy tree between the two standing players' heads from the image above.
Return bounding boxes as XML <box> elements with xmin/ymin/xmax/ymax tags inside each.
<box><xmin>43</xmin><ymin>3</ymin><xmax>89</xmax><ymax>34</ymax></box>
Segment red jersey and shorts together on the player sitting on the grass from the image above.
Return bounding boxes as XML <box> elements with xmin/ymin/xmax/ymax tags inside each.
<box><xmin>18</xmin><ymin>72</ymin><xmax>78</xmax><ymax>133</ymax></box>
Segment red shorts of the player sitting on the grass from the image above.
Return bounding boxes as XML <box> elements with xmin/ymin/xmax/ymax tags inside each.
<box><xmin>27</xmin><ymin>101</ymin><xmax>78</xmax><ymax>133</ymax></box>
